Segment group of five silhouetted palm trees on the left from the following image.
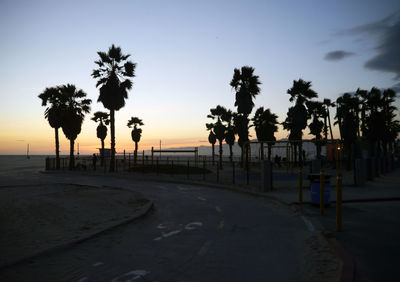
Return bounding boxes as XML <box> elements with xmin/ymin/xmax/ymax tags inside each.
<box><xmin>39</xmin><ymin>44</ymin><xmax>144</xmax><ymax>172</ymax></box>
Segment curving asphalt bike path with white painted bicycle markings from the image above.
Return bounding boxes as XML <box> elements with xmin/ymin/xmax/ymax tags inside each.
<box><xmin>0</xmin><ymin>158</ymin><xmax>332</xmax><ymax>281</ymax></box>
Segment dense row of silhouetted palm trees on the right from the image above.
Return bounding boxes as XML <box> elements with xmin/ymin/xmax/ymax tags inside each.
<box><xmin>206</xmin><ymin>66</ymin><xmax>400</xmax><ymax>168</ymax></box>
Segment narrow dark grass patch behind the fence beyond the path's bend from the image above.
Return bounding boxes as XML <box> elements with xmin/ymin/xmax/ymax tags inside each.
<box><xmin>130</xmin><ymin>164</ymin><xmax>211</xmax><ymax>174</ymax></box>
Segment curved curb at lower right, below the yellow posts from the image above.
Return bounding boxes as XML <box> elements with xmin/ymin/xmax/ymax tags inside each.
<box><xmin>321</xmin><ymin>232</ymin><xmax>356</xmax><ymax>282</ymax></box>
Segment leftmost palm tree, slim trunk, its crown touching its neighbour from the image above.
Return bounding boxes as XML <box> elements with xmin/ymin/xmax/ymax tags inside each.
<box><xmin>38</xmin><ymin>87</ymin><xmax>64</xmax><ymax>169</ymax></box>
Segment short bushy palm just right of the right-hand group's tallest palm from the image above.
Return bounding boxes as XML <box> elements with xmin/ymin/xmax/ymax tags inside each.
<box><xmin>252</xmin><ymin>107</ymin><xmax>278</xmax><ymax>161</ymax></box>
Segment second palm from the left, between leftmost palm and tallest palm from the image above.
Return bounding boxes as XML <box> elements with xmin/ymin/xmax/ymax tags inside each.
<box><xmin>59</xmin><ymin>84</ymin><xmax>92</xmax><ymax>170</ymax></box>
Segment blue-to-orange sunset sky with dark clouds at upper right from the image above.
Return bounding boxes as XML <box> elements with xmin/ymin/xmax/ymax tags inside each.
<box><xmin>0</xmin><ymin>0</ymin><xmax>400</xmax><ymax>154</ymax></box>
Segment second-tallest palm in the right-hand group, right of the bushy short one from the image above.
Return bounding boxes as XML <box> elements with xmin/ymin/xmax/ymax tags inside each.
<box><xmin>287</xmin><ymin>78</ymin><xmax>318</xmax><ymax>163</ymax></box>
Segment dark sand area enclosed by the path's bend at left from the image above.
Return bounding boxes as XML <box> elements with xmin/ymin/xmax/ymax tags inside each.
<box><xmin>0</xmin><ymin>184</ymin><xmax>148</xmax><ymax>266</ymax></box>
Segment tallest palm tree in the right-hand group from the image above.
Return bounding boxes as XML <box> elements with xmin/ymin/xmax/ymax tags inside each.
<box><xmin>230</xmin><ymin>66</ymin><xmax>261</xmax><ymax>164</ymax></box>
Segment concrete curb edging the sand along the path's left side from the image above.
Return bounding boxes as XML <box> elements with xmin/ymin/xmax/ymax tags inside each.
<box><xmin>0</xmin><ymin>200</ymin><xmax>154</xmax><ymax>270</ymax></box>
